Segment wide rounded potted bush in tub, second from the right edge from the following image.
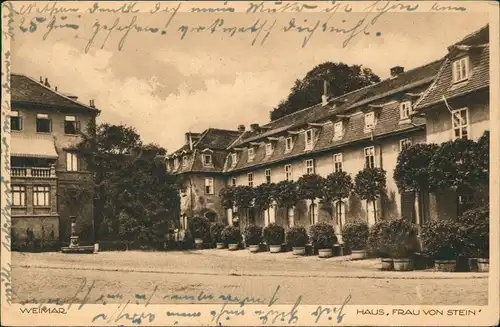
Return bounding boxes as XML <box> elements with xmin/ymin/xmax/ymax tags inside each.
<box><xmin>420</xmin><ymin>220</ymin><xmax>462</xmax><ymax>272</ymax></box>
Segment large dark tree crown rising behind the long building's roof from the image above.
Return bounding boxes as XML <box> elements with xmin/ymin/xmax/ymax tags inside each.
<box><xmin>271</xmin><ymin>62</ymin><xmax>380</xmax><ymax>120</ymax></box>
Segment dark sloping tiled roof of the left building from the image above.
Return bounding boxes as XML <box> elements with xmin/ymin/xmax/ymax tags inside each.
<box><xmin>11</xmin><ymin>74</ymin><xmax>99</xmax><ymax>111</ymax></box>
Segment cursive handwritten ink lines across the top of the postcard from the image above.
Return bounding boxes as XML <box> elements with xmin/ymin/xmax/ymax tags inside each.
<box><xmin>5</xmin><ymin>1</ymin><xmax>466</xmax><ymax>53</ymax></box>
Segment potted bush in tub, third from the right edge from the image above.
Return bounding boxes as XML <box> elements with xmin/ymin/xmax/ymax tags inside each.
<box><xmin>389</xmin><ymin>218</ymin><xmax>418</xmax><ymax>271</ymax></box>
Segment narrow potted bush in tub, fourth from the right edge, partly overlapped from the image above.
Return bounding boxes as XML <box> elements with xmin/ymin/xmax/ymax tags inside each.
<box><xmin>368</xmin><ymin>220</ymin><xmax>394</xmax><ymax>270</ymax></box>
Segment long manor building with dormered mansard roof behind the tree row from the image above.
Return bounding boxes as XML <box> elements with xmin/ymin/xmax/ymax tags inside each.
<box><xmin>167</xmin><ymin>26</ymin><xmax>489</xmax><ymax>233</ymax></box>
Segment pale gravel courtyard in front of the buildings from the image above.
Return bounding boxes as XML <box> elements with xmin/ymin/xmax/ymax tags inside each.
<box><xmin>12</xmin><ymin>250</ymin><xmax>488</xmax><ymax>305</ymax></box>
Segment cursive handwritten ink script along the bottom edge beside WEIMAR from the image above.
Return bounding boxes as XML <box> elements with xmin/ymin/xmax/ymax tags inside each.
<box><xmin>15</xmin><ymin>279</ymin><xmax>351</xmax><ymax>326</ymax></box>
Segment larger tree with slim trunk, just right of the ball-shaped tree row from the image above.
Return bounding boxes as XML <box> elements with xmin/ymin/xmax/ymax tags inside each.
<box><xmin>393</xmin><ymin>143</ymin><xmax>439</xmax><ymax>222</ymax></box>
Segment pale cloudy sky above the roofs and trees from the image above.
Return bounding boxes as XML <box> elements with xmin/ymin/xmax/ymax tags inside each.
<box><xmin>11</xmin><ymin>1</ymin><xmax>488</xmax><ymax>152</ymax></box>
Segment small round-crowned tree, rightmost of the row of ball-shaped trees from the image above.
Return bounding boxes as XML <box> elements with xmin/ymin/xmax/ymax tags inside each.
<box><xmin>354</xmin><ymin>168</ymin><xmax>386</xmax><ymax>221</ymax></box>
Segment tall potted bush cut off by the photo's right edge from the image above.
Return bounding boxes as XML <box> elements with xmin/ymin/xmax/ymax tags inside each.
<box><xmin>459</xmin><ymin>205</ymin><xmax>490</xmax><ymax>272</ymax></box>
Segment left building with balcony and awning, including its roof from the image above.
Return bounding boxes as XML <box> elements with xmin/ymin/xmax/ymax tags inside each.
<box><xmin>10</xmin><ymin>74</ymin><xmax>99</xmax><ymax>248</ymax></box>
